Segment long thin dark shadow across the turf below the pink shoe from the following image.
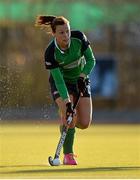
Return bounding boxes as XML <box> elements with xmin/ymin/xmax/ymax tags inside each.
<box><xmin>0</xmin><ymin>165</ymin><xmax>140</xmax><ymax>174</ymax></box>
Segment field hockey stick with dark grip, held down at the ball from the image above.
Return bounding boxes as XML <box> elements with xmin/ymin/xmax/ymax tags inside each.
<box><xmin>48</xmin><ymin>92</ymin><xmax>80</xmax><ymax>166</ymax></box>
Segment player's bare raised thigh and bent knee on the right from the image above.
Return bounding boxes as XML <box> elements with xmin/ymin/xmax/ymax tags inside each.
<box><xmin>77</xmin><ymin>97</ymin><xmax>92</xmax><ymax>129</ymax></box>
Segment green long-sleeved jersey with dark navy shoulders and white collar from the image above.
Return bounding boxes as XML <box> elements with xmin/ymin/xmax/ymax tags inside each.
<box><xmin>45</xmin><ymin>31</ymin><xmax>95</xmax><ymax>99</ymax></box>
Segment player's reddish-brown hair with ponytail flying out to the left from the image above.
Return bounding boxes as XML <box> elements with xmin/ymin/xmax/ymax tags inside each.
<box><xmin>35</xmin><ymin>15</ymin><xmax>69</xmax><ymax>33</ymax></box>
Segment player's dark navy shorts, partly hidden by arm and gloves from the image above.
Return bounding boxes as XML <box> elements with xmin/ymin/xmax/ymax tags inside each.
<box><xmin>49</xmin><ymin>75</ymin><xmax>91</xmax><ymax>101</ymax></box>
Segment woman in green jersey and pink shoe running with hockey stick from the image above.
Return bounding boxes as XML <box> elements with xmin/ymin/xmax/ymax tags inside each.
<box><xmin>36</xmin><ymin>16</ymin><xmax>95</xmax><ymax>165</ymax></box>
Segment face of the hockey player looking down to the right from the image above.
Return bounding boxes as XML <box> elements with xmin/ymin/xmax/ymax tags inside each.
<box><xmin>54</xmin><ymin>24</ymin><xmax>71</xmax><ymax>48</ymax></box>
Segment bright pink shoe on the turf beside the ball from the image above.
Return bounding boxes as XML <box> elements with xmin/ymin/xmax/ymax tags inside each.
<box><xmin>63</xmin><ymin>153</ymin><xmax>77</xmax><ymax>165</ymax></box>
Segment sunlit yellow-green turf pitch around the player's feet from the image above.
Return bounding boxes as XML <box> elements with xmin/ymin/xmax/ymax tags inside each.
<box><xmin>0</xmin><ymin>122</ymin><xmax>140</xmax><ymax>179</ymax></box>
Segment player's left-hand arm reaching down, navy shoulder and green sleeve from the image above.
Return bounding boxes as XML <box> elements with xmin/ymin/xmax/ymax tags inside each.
<box><xmin>45</xmin><ymin>42</ymin><xmax>70</xmax><ymax>103</ymax></box>
